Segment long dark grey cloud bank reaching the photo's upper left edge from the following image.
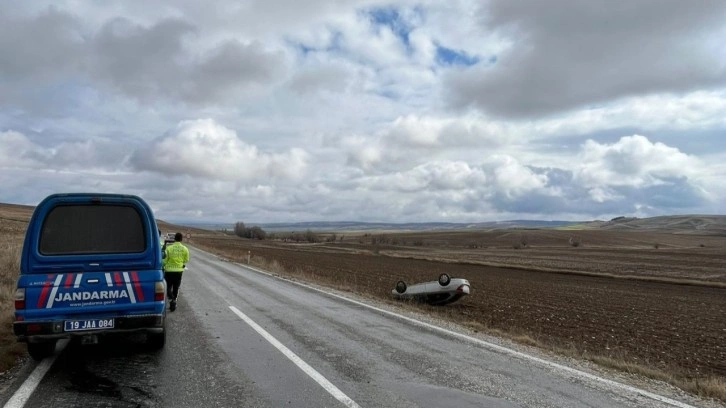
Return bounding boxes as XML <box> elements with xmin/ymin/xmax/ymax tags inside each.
<box><xmin>0</xmin><ymin>8</ymin><xmax>287</xmax><ymax>110</ymax></box>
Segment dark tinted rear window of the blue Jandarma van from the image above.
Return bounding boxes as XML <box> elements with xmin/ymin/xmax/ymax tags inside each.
<box><xmin>38</xmin><ymin>205</ymin><xmax>146</xmax><ymax>255</ymax></box>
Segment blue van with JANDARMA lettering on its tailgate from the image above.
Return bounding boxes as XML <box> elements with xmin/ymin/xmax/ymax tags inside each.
<box><xmin>13</xmin><ymin>193</ymin><xmax>166</xmax><ymax>360</ymax></box>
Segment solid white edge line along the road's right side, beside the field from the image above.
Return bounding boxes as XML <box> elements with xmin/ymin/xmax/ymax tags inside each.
<box><xmin>230</xmin><ymin>254</ymin><xmax>696</xmax><ymax>408</ymax></box>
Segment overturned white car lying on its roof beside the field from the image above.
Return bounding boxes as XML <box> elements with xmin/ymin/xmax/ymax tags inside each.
<box><xmin>391</xmin><ymin>273</ymin><xmax>471</xmax><ymax>305</ymax></box>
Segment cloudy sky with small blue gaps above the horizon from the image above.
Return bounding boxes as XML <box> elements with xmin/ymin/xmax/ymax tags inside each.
<box><xmin>0</xmin><ymin>0</ymin><xmax>726</xmax><ymax>223</ymax></box>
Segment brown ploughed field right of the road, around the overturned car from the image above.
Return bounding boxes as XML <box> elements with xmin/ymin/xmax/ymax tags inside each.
<box><xmin>192</xmin><ymin>232</ymin><xmax>726</xmax><ymax>378</ymax></box>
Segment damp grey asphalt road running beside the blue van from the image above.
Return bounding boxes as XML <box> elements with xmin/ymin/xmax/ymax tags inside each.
<box><xmin>0</xmin><ymin>249</ymin><xmax>708</xmax><ymax>408</ymax></box>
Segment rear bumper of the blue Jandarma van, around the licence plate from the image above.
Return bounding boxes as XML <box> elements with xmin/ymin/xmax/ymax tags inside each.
<box><xmin>13</xmin><ymin>314</ymin><xmax>164</xmax><ymax>343</ymax></box>
